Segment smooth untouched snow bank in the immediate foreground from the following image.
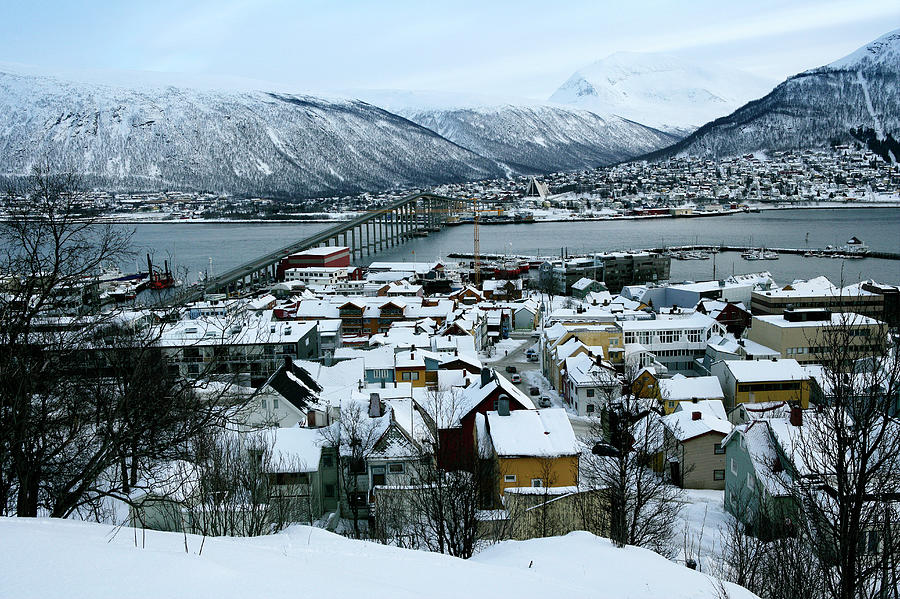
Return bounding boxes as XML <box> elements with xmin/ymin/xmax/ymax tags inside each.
<box><xmin>0</xmin><ymin>518</ymin><xmax>754</xmax><ymax>599</ymax></box>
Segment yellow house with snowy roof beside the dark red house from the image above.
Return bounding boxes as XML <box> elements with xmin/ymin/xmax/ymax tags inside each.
<box><xmin>475</xmin><ymin>408</ymin><xmax>579</xmax><ymax>498</ymax></box>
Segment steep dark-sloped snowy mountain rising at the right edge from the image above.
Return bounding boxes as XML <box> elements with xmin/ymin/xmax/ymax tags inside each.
<box><xmin>650</xmin><ymin>29</ymin><xmax>900</xmax><ymax>158</ymax></box>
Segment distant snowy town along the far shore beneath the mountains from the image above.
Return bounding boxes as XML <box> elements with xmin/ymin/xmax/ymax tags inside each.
<box><xmin>0</xmin><ymin>144</ymin><xmax>900</xmax><ymax>223</ymax></box>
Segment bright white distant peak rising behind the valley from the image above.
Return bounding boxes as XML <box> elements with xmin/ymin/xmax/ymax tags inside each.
<box><xmin>550</xmin><ymin>52</ymin><xmax>774</xmax><ymax>135</ymax></box>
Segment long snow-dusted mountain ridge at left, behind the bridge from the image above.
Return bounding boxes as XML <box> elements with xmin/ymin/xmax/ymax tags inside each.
<box><xmin>0</xmin><ymin>73</ymin><xmax>506</xmax><ymax>197</ymax></box>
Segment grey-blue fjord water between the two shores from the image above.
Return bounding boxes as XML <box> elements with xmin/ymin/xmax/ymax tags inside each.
<box><xmin>126</xmin><ymin>208</ymin><xmax>900</xmax><ymax>283</ymax></box>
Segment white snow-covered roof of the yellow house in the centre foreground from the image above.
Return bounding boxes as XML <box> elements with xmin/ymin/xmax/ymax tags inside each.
<box><xmin>487</xmin><ymin>408</ymin><xmax>579</xmax><ymax>458</ymax></box>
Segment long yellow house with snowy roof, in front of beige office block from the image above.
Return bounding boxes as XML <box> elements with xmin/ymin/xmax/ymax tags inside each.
<box><xmin>713</xmin><ymin>359</ymin><xmax>810</xmax><ymax>409</ymax></box>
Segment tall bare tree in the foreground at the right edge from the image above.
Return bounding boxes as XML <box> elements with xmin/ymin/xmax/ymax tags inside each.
<box><xmin>790</xmin><ymin>313</ymin><xmax>900</xmax><ymax>599</ymax></box>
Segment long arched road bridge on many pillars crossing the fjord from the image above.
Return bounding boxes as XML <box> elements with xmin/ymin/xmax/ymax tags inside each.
<box><xmin>170</xmin><ymin>193</ymin><xmax>472</xmax><ymax>303</ymax></box>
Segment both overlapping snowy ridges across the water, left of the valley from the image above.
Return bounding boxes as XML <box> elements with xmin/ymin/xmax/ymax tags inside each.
<box><xmin>0</xmin><ymin>69</ymin><xmax>676</xmax><ymax>197</ymax></box>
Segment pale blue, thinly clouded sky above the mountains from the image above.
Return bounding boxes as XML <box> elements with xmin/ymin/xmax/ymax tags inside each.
<box><xmin>0</xmin><ymin>0</ymin><xmax>900</xmax><ymax>100</ymax></box>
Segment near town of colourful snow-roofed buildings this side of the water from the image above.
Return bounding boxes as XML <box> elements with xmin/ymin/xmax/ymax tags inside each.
<box><xmin>15</xmin><ymin>238</ymin><xmax>900</xmax><ymax>545</ymax></box>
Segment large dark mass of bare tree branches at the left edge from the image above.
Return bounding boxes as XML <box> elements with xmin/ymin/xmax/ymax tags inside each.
<box><xmin>0</xmin><ymin>168</ymin><xmax>253</xmax><ymax>517</ymax></box>
